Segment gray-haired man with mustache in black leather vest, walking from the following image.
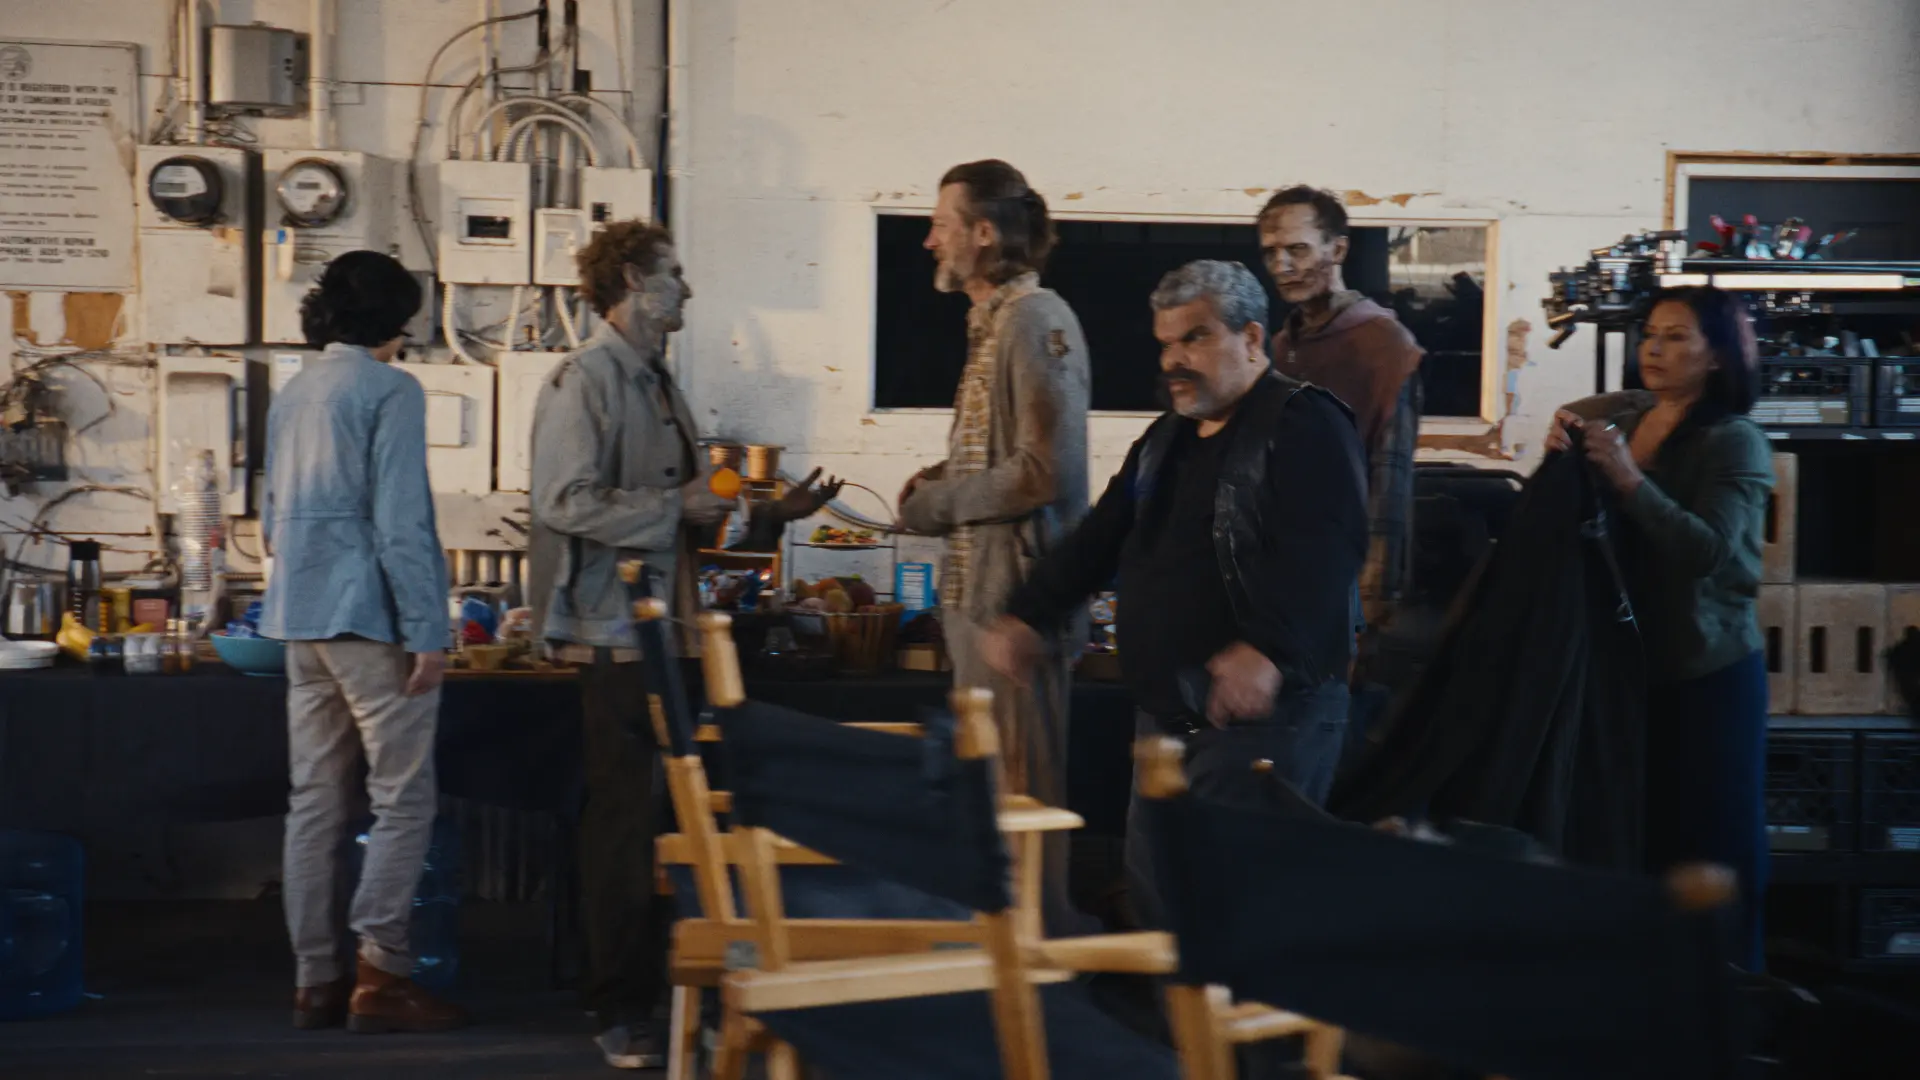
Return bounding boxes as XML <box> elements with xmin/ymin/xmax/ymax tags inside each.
<box><xmin>981</xmin><ymin>261</ymin><xmax>1367</xmax><ymax>926</ymax></box>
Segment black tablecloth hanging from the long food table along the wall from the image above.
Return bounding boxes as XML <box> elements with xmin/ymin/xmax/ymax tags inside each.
<box><xmin>0</xmin><ymin>667</ymin><xmax>1133</xmax><ymax>836</ymax></box>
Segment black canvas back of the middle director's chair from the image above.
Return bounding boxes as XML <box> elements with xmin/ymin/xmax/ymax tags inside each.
<box><xmin>720</xmin><ymin>701</ymin><xmax>1012</xmax><ymax>913</ymax></box>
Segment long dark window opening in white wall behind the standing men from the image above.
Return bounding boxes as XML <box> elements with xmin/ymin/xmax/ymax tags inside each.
<box><xmin>874</xmin><ymin>213</ymin><xmax>1486</xmax><ymax>417</ymax></box>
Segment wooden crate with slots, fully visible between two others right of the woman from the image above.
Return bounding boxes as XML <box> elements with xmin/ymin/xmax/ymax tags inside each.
<box><xmin>1793</xmin><ymin>582</ymin><xmax>1887</xmax><ymax>717</ymax></box>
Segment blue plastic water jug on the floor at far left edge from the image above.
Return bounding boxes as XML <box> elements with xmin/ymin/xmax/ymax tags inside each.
<box><xmin>0</xmin><ymin>828</ymin><xmax>84</xmax><ymax>1020</ymax></box>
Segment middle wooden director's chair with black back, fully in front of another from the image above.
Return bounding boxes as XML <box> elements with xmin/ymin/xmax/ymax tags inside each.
<box><xmin>714</xmin><ymin>690</ymin><xmax>1338</xmax><ymax>1080</ymax></box>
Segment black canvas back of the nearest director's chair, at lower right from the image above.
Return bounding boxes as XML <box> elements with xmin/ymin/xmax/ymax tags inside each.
<box><xmin>1144</xmin><ymin>798</ymin><xmax>1730</xmax><ymax>1080</ymax></box>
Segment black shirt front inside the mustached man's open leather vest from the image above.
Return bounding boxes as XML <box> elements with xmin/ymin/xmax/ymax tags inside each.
<box><xmin>1116</xmin><ymin>421</ymin><xmax>1240</xmax><ymax>717</ymax></box>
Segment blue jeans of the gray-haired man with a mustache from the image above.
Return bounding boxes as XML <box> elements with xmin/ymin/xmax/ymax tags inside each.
<box><xmin>1127</xmin><ymin>682</ymin><xmax>1348</xmax><ymax>930</ymax></box>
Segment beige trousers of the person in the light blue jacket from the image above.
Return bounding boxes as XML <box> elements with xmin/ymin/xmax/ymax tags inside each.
<box><xmin>282</xmin><ymin>640</ymin><xmax>440</xmax><ymax>986</ymax></box>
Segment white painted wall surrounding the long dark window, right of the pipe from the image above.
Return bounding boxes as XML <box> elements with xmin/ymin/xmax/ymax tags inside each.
<box><xmin>685</xmin><ymin>0</ymin><xmax>1920</xmax><ymax>545</ymax></box>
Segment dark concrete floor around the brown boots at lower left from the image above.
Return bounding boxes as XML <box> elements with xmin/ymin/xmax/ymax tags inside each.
<box><xmin>0</xmin><ymin>901</ymin><xmax>637</xmax><ymax>1080</ymax></box>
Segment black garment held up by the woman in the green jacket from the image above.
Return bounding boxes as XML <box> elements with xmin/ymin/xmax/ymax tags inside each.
<box><xmin>1329</xmin><ymin>445</ymin><xmax>1645</xmax><ymax>871</ymax></box>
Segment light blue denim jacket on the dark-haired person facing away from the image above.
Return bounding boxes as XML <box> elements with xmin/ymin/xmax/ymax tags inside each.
<box><xmin>259</xmin><ymin>344</ymin><xmax>449</xmax><ymax>653</ymax></box>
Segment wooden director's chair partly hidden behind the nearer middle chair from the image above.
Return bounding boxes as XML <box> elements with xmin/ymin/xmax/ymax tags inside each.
<box><xmin>620</xmin><ymin>561</ymin><xmax>1081</xmax><ymax>1080</ymax></box>
